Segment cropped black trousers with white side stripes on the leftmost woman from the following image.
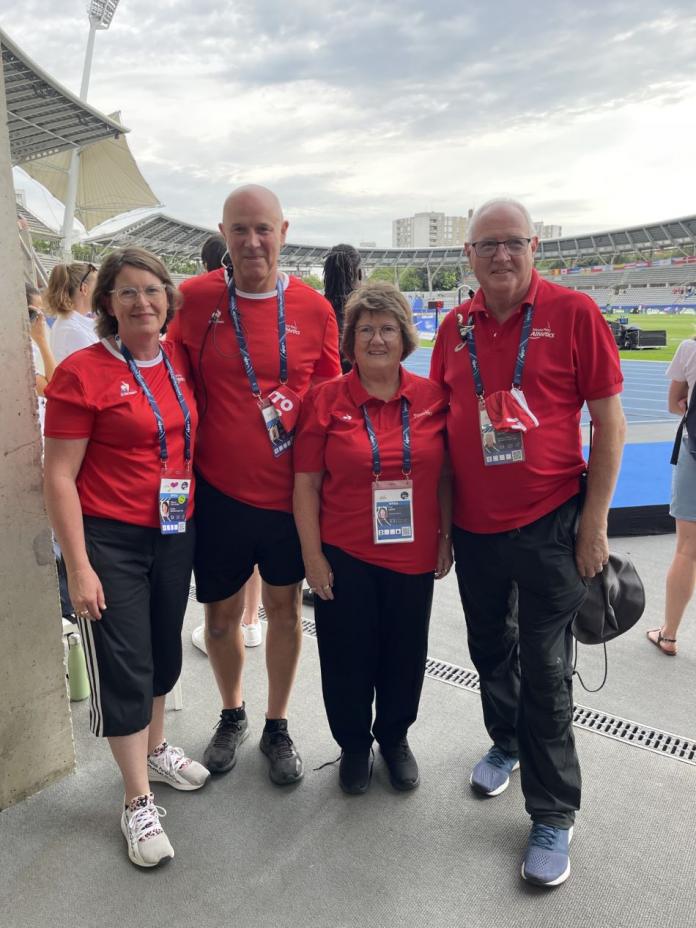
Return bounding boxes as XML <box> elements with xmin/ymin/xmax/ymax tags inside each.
<box><xmin>78</xmin><ymin>516</ymin><xmax>195</xmax><ymax>737</ymax></box>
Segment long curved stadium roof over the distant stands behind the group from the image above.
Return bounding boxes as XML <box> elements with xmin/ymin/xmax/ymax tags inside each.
<box><xmin>87</xmin><ymin>213</ymin><xmax>696</xmax><ymax>272</ymax></box>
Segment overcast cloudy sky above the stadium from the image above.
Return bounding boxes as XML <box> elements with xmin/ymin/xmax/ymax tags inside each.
<box><xmin>0</xmin><ymin>0</ymin><xmax>696</xmax><ymax>245</ymax></box>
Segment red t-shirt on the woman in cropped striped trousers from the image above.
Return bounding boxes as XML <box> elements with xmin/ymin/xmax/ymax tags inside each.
<box><xmin>46</xmin><ymin>342</ymin><xmax>198</xmax><ymax>527</ymax></box>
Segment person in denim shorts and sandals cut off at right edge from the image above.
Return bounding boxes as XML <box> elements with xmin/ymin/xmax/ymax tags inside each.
<box><xmin>647</xmin><ymin>338</ymin><xmax>696</xmax><ymax>657</ymax></box>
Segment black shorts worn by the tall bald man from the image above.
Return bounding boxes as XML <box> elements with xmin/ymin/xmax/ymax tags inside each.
<box><xmin>193</xmin><ymin>474</ymin><xmax>304</xmax><ymax>603</ymax></box>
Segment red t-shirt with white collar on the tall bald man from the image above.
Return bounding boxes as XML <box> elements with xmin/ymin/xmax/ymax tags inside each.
<box><xmin>167</xmin><ymin>269</ymin><xmax>341</xmax><ymax>512</ymax></box>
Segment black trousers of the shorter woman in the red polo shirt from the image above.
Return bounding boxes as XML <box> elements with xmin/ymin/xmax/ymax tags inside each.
<box><xmin>314</xmin><ymin>545</ymin><xmax>434</xmax><ymax>751</ymax></box>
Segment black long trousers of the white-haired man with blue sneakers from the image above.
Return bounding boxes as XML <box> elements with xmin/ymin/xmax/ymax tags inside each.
<box><xmin>453</xmin><ymin>498</ymin><xmax>586</xmax><ymax>828</ymax></box>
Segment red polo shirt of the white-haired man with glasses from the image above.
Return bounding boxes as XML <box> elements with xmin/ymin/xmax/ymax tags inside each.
<box><xmin>430</xmin><ymin>271</ymin><xmax>623</xmax><ymax>533</ymax></box>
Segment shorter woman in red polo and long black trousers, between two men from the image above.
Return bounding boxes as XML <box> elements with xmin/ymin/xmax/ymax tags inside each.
<box><xmin>294</xmin><ymin>281</ymin><xmax>452</xmax><ymax>793</ymax></box>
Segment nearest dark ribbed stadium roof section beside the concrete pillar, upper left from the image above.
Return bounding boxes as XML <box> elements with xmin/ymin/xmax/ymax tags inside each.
<box><xmin>0</xmin><ymin>29</ymin><xmax>128</xmax><ymax>164</ymax></box>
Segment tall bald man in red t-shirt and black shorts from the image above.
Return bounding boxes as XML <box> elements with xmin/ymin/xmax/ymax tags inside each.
<box><xmin>169</xmin><ymin>186</ymin><xmax>341</xmax><ymax>785</ymax></box>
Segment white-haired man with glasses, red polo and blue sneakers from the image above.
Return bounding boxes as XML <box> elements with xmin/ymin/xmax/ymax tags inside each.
<box><xmin>430</xmin><ymin>199</ymin><xmax>625</xmax><ymax>886</ymax></box>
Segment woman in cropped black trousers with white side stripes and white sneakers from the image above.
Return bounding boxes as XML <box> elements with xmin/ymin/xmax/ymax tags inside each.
<box><xmin>45</xmin><ymin>248</ymin><xmax>209</xmax><ymax>867</ymax></box>
